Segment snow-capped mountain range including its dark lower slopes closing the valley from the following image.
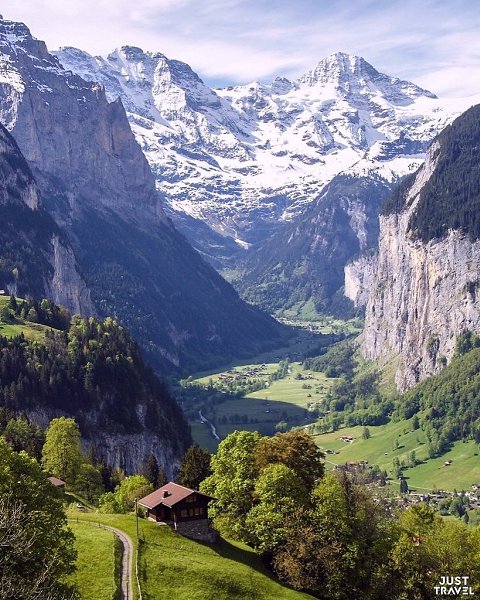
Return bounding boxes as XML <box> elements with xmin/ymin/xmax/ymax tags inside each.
<box><xmin>55</xmin><ymin>46</ymin><xmax>474</xmax><ymax>314</ymax></box>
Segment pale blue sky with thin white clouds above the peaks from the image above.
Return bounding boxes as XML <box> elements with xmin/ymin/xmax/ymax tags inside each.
<box><xmin>0</xmin><ymin>0</ymin><xmax>480</xmax><ymax>97</ymax></box>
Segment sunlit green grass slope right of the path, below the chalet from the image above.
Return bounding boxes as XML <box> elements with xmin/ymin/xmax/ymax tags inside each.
<box><xmin>71</xmin><ymin>513</ymin><xmax>311</xmax><ymax>600</ymax></box>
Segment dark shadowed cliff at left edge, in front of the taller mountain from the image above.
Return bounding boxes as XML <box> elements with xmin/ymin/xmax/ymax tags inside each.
<box><xmin>0</xmin><ymin>119</ymin><xmax>93</xmax><ymax>313</ymax></box>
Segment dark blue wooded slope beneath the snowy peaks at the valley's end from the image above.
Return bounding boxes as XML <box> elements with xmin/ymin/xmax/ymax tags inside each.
<box><xmin>237</xmin><ymin>174</ymin><xmax>391</xmax><ymax>316</ymax></box>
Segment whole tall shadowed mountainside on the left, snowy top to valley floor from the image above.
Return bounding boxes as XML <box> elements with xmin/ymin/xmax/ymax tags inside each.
<box><xmin>0</xmin><ymin>21</ymin><xmax>281</xmax><ymax>370</ymax></box>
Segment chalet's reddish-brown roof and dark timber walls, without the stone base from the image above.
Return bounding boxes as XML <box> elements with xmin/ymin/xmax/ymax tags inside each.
<box><xmin>138</xmin><ymin>482</ymin><xmax>213</xmax><ymax>529</ymax></box>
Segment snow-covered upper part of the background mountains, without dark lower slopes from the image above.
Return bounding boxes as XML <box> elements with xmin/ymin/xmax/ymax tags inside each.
<box><xmin>56</xmin><ymin>46</ymin><xmax>475</xmax><ymax>259</ymax></box>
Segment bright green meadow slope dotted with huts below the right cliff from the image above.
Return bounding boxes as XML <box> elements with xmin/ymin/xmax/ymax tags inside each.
<box><xmin>315</xmin><ymin>421</ymin><xmax>480</xmax><ymax>491</ymax></box>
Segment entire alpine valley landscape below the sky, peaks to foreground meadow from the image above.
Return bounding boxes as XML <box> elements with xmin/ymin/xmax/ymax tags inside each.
<box><xmin>0</xmin><ymin>11</ymin><xmax>480</xmax><ymax>600</ymax></box>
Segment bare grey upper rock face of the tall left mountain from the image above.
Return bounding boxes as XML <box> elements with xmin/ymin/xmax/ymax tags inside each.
<box><xmin>0</xmin><ymin>21</ymin><xmax>164</xmax><ymax>224</ymax></box>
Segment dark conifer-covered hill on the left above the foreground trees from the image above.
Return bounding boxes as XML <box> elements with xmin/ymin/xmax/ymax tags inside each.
<box><xmin>0</xmin><ymin>300</ymin><xmax>191</xmax><ymax>474</ymax></box>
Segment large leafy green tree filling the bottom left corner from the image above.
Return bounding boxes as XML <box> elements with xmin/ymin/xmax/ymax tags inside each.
<box><xmin>0</xmin><ymin>438</ymin><xmax>76</xmax><ymax>600</ymax></box>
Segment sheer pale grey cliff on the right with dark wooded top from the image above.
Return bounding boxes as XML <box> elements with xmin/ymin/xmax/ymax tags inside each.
<box><xmin>358</xmin><ymin>107</ymin><xmax>480</xmax><ymax>391</ymax></box>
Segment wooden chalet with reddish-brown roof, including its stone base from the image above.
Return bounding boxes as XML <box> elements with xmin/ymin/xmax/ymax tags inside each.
<box><xmin>138</xmin><ymin>482</ymin><xmax>217</xmax><ymax>541</ymax></box>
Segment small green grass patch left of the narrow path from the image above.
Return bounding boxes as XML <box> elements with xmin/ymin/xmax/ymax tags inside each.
<box><xmin>68</xmin><ymin>521</ymin><xmax>115</xmax><ymax>600</ymax></box>
